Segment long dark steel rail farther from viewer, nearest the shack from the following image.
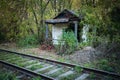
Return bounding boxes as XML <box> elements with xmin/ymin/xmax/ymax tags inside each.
<box><xmin>0</xmin><ymin>49</ymin><xmax>120</xmax><ymax>78</ymax></box>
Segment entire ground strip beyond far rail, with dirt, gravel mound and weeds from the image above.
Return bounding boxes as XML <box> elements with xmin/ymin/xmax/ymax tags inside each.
<box><xmin>0</xmin><ymin>43</ymin><xmax>120</xmax><ymax>73</ymax></box>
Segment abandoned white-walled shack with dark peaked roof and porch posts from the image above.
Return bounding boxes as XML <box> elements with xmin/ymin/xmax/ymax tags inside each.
<box><xmin>45</xmin><ymin>9</ymin><xmax>80</xmax><ymax>44</ymax></box>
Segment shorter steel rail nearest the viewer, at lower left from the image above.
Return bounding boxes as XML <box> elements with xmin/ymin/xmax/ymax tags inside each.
<box><xmin>0</xmin><ymin>60</ymin><xmax>55</xmax><ymax>80</ymax></box>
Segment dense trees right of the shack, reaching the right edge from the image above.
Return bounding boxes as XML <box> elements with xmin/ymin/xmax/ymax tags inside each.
<box><xmin>79</xmin><ymin>0</ymin><xmax>120</xmax><ymax>46</ymax></box>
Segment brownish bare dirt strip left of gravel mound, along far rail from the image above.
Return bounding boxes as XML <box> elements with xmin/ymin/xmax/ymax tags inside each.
<box><xmin>0</xmin><ymin>43</ymin><xmax>58</xmax><ymax>59</ymax></box>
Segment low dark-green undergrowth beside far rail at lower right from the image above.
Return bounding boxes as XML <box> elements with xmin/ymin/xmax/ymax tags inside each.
<box><xmin>84</xmin><ymin>58</ymin><xmax>120</xmax><ymax>74</ymax></box>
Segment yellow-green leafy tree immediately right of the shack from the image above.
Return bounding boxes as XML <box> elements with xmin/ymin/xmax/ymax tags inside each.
<box><xmin>80</xmin><ymin>6</ymin><xmax>102</xmax><ymax>46</ymax></box>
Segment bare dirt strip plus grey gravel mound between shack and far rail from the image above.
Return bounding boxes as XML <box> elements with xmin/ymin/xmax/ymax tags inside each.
<box><xmin>0</xmin><ymin>43</ymin><xmax>98</xmax><ymax>65</ymax></box>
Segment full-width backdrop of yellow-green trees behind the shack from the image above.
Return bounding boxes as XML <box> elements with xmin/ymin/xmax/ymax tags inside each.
<box><xmin>0</xmin><ymin>0</ymin><xmax>120</xmax><ymax>45</ymax></box>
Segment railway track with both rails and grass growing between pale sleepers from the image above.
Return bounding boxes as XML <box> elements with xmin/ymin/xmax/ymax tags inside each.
<box><xmin>0</xmin><ymin>49</ymin><xmax>120</xmax><ymax>80</ymax></box>
